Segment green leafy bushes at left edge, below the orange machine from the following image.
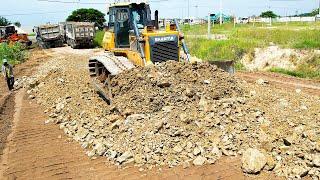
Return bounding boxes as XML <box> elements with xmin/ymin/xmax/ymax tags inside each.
<box><xmin>0</xmin><ymin>43</ymin><xmax>27</xmax><ymax>65</ymax></box>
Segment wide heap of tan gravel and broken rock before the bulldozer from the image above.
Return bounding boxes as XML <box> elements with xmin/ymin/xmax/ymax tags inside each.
<box><xmin>16</xmin><ymin>48</ymin><xmax>320</xmax><ymax>178</ymax></box>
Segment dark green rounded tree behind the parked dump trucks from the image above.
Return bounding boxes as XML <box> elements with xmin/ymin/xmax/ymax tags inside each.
<box><xmin>67</xmin><ymin>8</ymin><xmax>106</xmax><ymax>29</ymax></box>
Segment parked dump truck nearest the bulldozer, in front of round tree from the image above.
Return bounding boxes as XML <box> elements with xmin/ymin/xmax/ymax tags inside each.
<box><xmin>66</xmin><ymin>22</ymin><xmax>95</xmax><ymax>49</ymax></box>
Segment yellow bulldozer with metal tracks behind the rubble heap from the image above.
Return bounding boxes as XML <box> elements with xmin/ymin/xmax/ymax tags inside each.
<box><xmin>89</xmin><ymin>2</ymin><xmax>190</xmax><ymax>104</ymax></box>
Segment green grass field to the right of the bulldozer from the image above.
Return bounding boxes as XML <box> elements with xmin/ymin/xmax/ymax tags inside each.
<box><xmin>182</xmin><ymin>22</ymin><xmax>320</xmax><ymax>78</ymax></box>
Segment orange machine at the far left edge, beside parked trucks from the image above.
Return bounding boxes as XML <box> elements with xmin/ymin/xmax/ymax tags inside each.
<box><xmin>0</xmin><ymin>25</ymin><xmax>32</xmax><ymax>47</ymax></box>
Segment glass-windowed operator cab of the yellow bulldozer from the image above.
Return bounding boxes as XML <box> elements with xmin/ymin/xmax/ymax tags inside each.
<box><xmin>109</xmin><ymin>3</ymin><xmax>151</xmax><ymax>48</ymax></box>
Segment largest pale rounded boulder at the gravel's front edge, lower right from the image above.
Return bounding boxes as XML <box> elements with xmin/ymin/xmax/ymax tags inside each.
<box><xmin>242</xmin><ymin>148</ymin><xmax>267</xmax><ymax>174</ymax></box>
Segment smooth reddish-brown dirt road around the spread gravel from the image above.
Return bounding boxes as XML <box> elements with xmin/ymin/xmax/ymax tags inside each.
<box><xmin>0</xmin><ymin>48</ymin><xmax>317</xmax><ymax>179</ymax></box>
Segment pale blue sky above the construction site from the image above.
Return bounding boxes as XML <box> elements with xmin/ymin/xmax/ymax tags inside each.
<box><xmin>0</xmin><ymin>0</ymin><xmax>320</xmax><ymax>31</ymax></box>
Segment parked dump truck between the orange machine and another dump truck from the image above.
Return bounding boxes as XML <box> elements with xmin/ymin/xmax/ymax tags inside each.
<box><xmin>33</xmin><ymin>24</ymin><xmax>63</xmax><ymax>49</ymax></box>
